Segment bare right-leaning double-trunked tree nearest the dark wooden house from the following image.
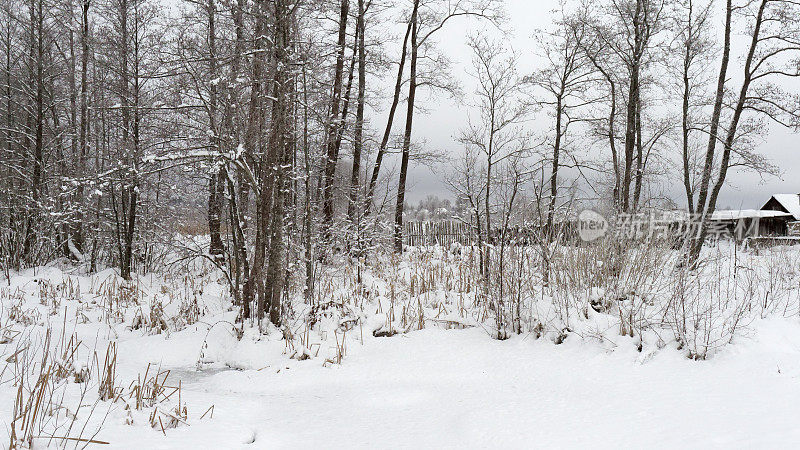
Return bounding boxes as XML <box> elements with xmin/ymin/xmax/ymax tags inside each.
<box><xmin>688</xmin><ymin>0</ymin><xmax>800</xmax><ymax>265</ymax></box>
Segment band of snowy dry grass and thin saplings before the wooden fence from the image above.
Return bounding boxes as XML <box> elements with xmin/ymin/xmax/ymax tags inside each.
<box><xmin>288</xmin><ymin>239</ymin><xmax>800</xmax><ymax>364</ymax></box>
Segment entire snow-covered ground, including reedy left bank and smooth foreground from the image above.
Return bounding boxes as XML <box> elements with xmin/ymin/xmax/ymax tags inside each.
<box><xmin>0</xmin><ymin>244</ymin><xmax>800</xmax><ymax>448</ymax></box>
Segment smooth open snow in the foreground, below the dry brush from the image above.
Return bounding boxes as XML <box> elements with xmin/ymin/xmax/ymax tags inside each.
<box><xmin>81</xmin><ymin>321</ymin><xmax>800</xmax><ymax>448</ymax></box>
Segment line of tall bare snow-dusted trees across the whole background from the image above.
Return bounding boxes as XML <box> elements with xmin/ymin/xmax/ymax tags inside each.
<box><xmin>0</xmin><ymin>0</ymin><xmax>800</xmax><ymax>324</ymax></box>
